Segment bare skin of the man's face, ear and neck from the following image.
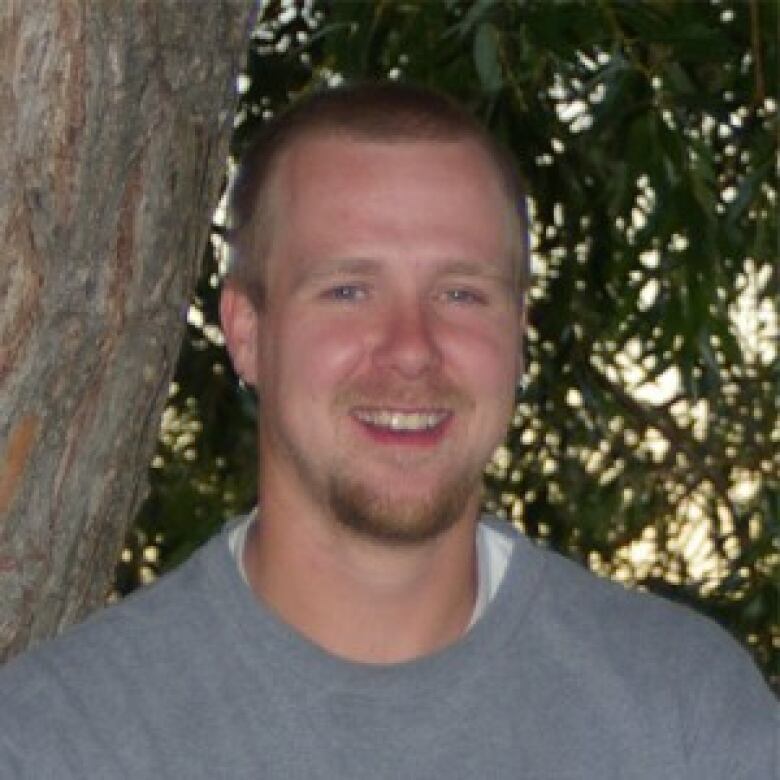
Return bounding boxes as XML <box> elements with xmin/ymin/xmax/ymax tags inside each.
<box><xmin>221</xmin><ymin>137</ymin><xmax>522</xmax><ymax>663</ymax></box>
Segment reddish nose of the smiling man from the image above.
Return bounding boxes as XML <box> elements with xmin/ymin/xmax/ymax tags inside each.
<box><xmin>373</xmin><ymin>301</ymin><xmax>441</xmax><ymax>379</ymax></box>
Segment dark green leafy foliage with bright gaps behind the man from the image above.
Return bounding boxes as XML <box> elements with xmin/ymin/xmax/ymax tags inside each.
<box><xmin>113</xmin><ymin>0</ymin><xmax>780</xmax><ymax>684</ymax></box>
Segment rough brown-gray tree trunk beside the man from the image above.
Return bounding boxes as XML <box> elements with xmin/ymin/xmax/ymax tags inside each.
<box><xmin>0</xmin><ymin>0</ymin><xmax>253</xmax><ymax>658</ymax></box>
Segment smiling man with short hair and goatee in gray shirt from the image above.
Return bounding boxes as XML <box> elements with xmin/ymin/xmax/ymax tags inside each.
<box><xmin>0</xmin><ymin>84</ymin><xmax>777</xmax><ymax>780</ymax></box>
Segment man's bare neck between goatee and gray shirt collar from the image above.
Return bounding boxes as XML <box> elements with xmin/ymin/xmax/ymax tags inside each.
<box><xmin>244</xmin><ymin>478</ymin><xmax>477</xmax><ymax>663</ymax></box>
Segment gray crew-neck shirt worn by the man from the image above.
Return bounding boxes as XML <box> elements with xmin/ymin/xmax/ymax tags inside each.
<box><xmin>0</xmin><ymin>516</ymin><xmax>778</xmax><ymax>780</ymax></box>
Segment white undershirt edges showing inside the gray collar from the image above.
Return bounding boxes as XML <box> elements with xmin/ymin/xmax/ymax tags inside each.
<box><xmin>228</xmin><ymin>509</ymin><xmax>512</xmax><ymax>630</ymax></box>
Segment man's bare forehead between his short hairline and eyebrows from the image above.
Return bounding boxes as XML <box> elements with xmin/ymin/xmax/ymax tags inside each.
<box><xmin>270</xmin><ymin>136</ymin><xmax>511</xmax><ymax>262</ymax></box>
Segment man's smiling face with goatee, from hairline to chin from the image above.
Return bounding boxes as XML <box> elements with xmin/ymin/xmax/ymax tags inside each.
<box><xmin>235</xmin><ymin>138</ymin><xmax>520</xmax><ymax>542</ymax></box>
